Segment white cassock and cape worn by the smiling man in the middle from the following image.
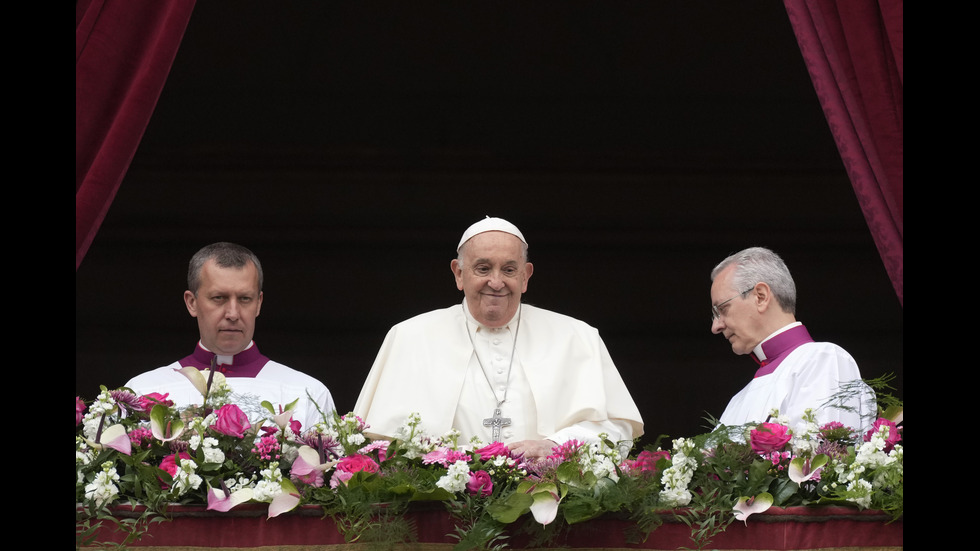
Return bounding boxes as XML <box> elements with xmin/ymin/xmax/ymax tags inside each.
<box><xmin>354</xmin><ymin>301</ymin><xmax>643</xmax><ymax>444</ymax></box>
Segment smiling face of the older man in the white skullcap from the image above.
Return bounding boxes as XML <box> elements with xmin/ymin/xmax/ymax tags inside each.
<box><xmin>451</xmin><ymin>231</ymin><xmax>534</xmax><ymax>327</ymax></box>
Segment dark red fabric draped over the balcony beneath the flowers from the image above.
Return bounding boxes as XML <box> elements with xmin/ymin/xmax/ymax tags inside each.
<box><xmin>90</xmin><ymin>504</ymin><xmax>904</xmax><ymax>551</ymax></box>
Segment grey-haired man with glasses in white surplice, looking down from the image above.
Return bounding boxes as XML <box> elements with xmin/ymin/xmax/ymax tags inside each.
<box><xmin>711</xmin><ymin>247</ymin><xmax>877</xmax><ymax>432</ymax></box>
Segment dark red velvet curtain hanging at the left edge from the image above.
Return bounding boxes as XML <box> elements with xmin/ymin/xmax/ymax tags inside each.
<box><xmin>75</xmin><ymin>0</ymin><xmax>195</xmax><ymax>271</ymax></box>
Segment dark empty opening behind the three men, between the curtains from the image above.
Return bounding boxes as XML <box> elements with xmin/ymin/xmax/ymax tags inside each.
<box><xmin>75</xmin><ymin>0</ymin><xmax>904</xmax><ymax>448</ymax></box>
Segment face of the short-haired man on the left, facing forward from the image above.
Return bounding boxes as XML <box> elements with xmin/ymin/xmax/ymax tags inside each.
<box><xmin>184</xmin><ymin>260</ymin><xmax>262</xmax><ymax>355</ymax></box>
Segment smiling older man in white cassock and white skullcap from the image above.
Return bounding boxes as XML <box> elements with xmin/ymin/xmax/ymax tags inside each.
<box><xmin>354</xmin><ymin>217</ymin><xmax>643</xmax><ymax>458</ymax></box>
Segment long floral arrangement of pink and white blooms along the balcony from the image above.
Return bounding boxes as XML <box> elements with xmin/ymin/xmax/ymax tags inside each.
<box><xmin>75</xmin><ymin>369</ymin><xmax>903</xmax><ymax>550</ymax></box>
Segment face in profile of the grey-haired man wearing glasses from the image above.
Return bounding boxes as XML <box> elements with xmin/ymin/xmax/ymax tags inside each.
<box><xmin>711</xmin><ymin>265</ymin><xmax>766</xmax><ymax>354</ymax></box>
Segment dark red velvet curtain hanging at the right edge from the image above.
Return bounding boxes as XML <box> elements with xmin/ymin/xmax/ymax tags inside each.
<box><xmin>784</xmin><ymin>0</ymin><xmax>904</xmax><ymax>306</ymax></box>
